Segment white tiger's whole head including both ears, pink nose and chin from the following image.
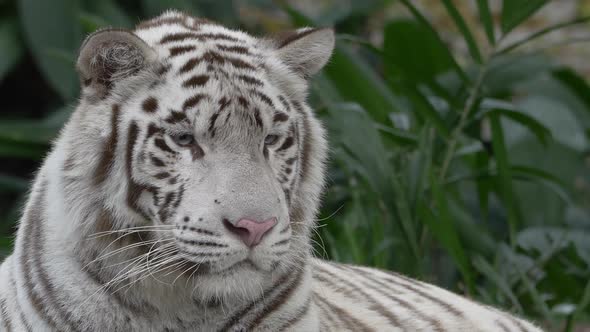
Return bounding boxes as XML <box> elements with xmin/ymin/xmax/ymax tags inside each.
<box><xmin>71</xmin><ymin>12</ymin><xmax>334</xmax><ymax>298</ymax></box>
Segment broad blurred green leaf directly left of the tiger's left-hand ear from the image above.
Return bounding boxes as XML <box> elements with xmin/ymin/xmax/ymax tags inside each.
<box><xmin>18</xmin><ymin>0</ymin><xmax>82</xmax><ymax>101</ymax></box>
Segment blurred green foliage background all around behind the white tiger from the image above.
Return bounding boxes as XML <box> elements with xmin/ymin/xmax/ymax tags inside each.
<box><xmin>0</xmin><ymin>0</ymin><xmax>590</xmax><ymax>330</ymax></box>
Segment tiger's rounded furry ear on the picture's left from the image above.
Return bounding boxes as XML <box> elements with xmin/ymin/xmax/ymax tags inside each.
<box><xmin>76</xmin><ymin>29</ymin><xmax>157</xmax><ymax>97</ymax></box>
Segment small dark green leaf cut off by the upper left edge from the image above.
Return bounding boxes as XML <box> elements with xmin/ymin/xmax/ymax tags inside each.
<box><xmin>0</xmin><ymin>18</ymin><xmax>24</xmax><ymax>82</ymax></box>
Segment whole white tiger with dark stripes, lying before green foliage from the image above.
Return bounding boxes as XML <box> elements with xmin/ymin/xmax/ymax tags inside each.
<box><xmin>0</xmin><ymin>11</ymin><xmax>539</xmax><ymax>332</ymax></box>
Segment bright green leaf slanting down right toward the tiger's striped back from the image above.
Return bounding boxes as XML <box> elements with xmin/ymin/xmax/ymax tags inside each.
<box><xmin>420</xmin><ymin>176</ymin><xmax>475</xmax><ymax>294</ymax></box>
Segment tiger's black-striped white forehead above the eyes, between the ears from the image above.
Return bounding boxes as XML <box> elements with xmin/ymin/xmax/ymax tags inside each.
<box><xmin>136</xmin><ymin>15</ymin><xmax>290</xmax><ymax>124</ymax></box>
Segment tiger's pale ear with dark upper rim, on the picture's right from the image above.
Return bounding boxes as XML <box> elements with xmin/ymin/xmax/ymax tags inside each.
<box><xmin>274</xmin><ymin>28</ymin><xmax>335</xmax><ymax>78</ymax></box>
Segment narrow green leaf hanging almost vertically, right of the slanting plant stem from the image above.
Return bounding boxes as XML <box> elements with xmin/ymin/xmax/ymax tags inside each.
<box><xmin>489</xmin><ymin>114</ymin><xmax>520</xmax><ymax>246</ymax></box>
